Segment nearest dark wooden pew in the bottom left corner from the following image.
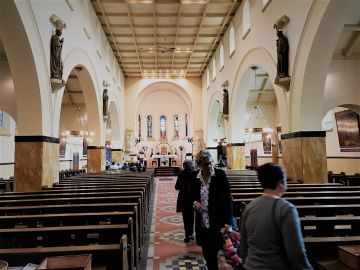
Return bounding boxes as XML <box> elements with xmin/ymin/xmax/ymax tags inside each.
<box><xmin>0</xmin><ymin>218</ymin><xmax>135</xmax><ymax>270</ymax></box>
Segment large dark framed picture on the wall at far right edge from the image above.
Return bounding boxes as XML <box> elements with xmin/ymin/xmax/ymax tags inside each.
<box><xmin>335</xmin><ymin>110</ymin><xmax>360</xmax><ymax>152</ymax></box>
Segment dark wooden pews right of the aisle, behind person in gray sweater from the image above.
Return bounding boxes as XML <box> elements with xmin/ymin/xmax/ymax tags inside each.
<box><xmin>228</xmin><ymin>174</ymin><xmax>360</xmax><ymax>269</ymax></box>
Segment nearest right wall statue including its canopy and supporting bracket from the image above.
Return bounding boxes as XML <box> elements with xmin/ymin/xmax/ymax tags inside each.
<box><xmin>274</xmin><ymin>15</ymin><xmax>290</xmax><ymax>90</ymax></box>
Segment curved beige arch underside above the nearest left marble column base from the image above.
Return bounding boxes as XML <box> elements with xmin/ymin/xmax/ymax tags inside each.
<box><xmin>0</xmin><ymin>1</ymin><xmax>42</xmax><ymax>135</ymax></box>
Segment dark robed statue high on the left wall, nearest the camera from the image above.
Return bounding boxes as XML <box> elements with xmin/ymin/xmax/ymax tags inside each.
<box><xmin>50</xmin><ymin>28</ymin><xmax>64</xmax><ymax>80</ymax></box>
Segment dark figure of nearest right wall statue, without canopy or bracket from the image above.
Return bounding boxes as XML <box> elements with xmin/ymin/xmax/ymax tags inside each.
<box><xmin>276</xmin><ymin>30</ymin><xmax>289</xmax><ymax>78</ymax></box>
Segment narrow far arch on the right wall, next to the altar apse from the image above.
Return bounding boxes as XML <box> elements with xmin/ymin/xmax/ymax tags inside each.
<box><xmin>205</xmin><ymin>91</ymin><xmax>226</xmax><ymax>147</ymax></box>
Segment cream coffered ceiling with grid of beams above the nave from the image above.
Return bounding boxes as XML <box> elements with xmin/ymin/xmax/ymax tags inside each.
<box><xmin>91</xmin><ymin>0</ymin><xmax>241</xmax><ymax>78</ymax></box>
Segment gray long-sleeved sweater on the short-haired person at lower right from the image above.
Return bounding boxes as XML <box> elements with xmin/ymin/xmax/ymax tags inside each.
<box><xmin>240</xmin><ymin>196</ymin><xmax>313</xmax><ymax>270</ymax></box>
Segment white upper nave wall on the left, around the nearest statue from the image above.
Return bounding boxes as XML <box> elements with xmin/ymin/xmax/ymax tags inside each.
<box><xmin>12</xmin><ymin>1</ymin><xmax>124</xmax><ymax>137</ymax></box>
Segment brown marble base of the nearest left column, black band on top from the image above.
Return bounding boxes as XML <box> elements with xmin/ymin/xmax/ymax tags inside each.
<box><xmin>14</xmin><ymin>136</ymin><xmax>59</xmax><ymax>192</ymax></box>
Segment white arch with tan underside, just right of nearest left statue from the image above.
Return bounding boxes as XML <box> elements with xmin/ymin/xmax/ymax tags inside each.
<box><xmin>53</xmin><ymin>48</ymin><xmax>102</xmax><ymax>146</ymax></box>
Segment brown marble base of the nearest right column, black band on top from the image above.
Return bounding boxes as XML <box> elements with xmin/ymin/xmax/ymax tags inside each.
<box><xmin>281</xmin><ymin>131</ymin><xmax>327</xmax><ymax>183</ymax></box>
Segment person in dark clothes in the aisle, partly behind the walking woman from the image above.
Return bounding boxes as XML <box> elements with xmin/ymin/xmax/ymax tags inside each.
<box><xmin>175</xmin><ymin>160</ymin><xmax>195</xmax><ymax>243</ymax></box>
